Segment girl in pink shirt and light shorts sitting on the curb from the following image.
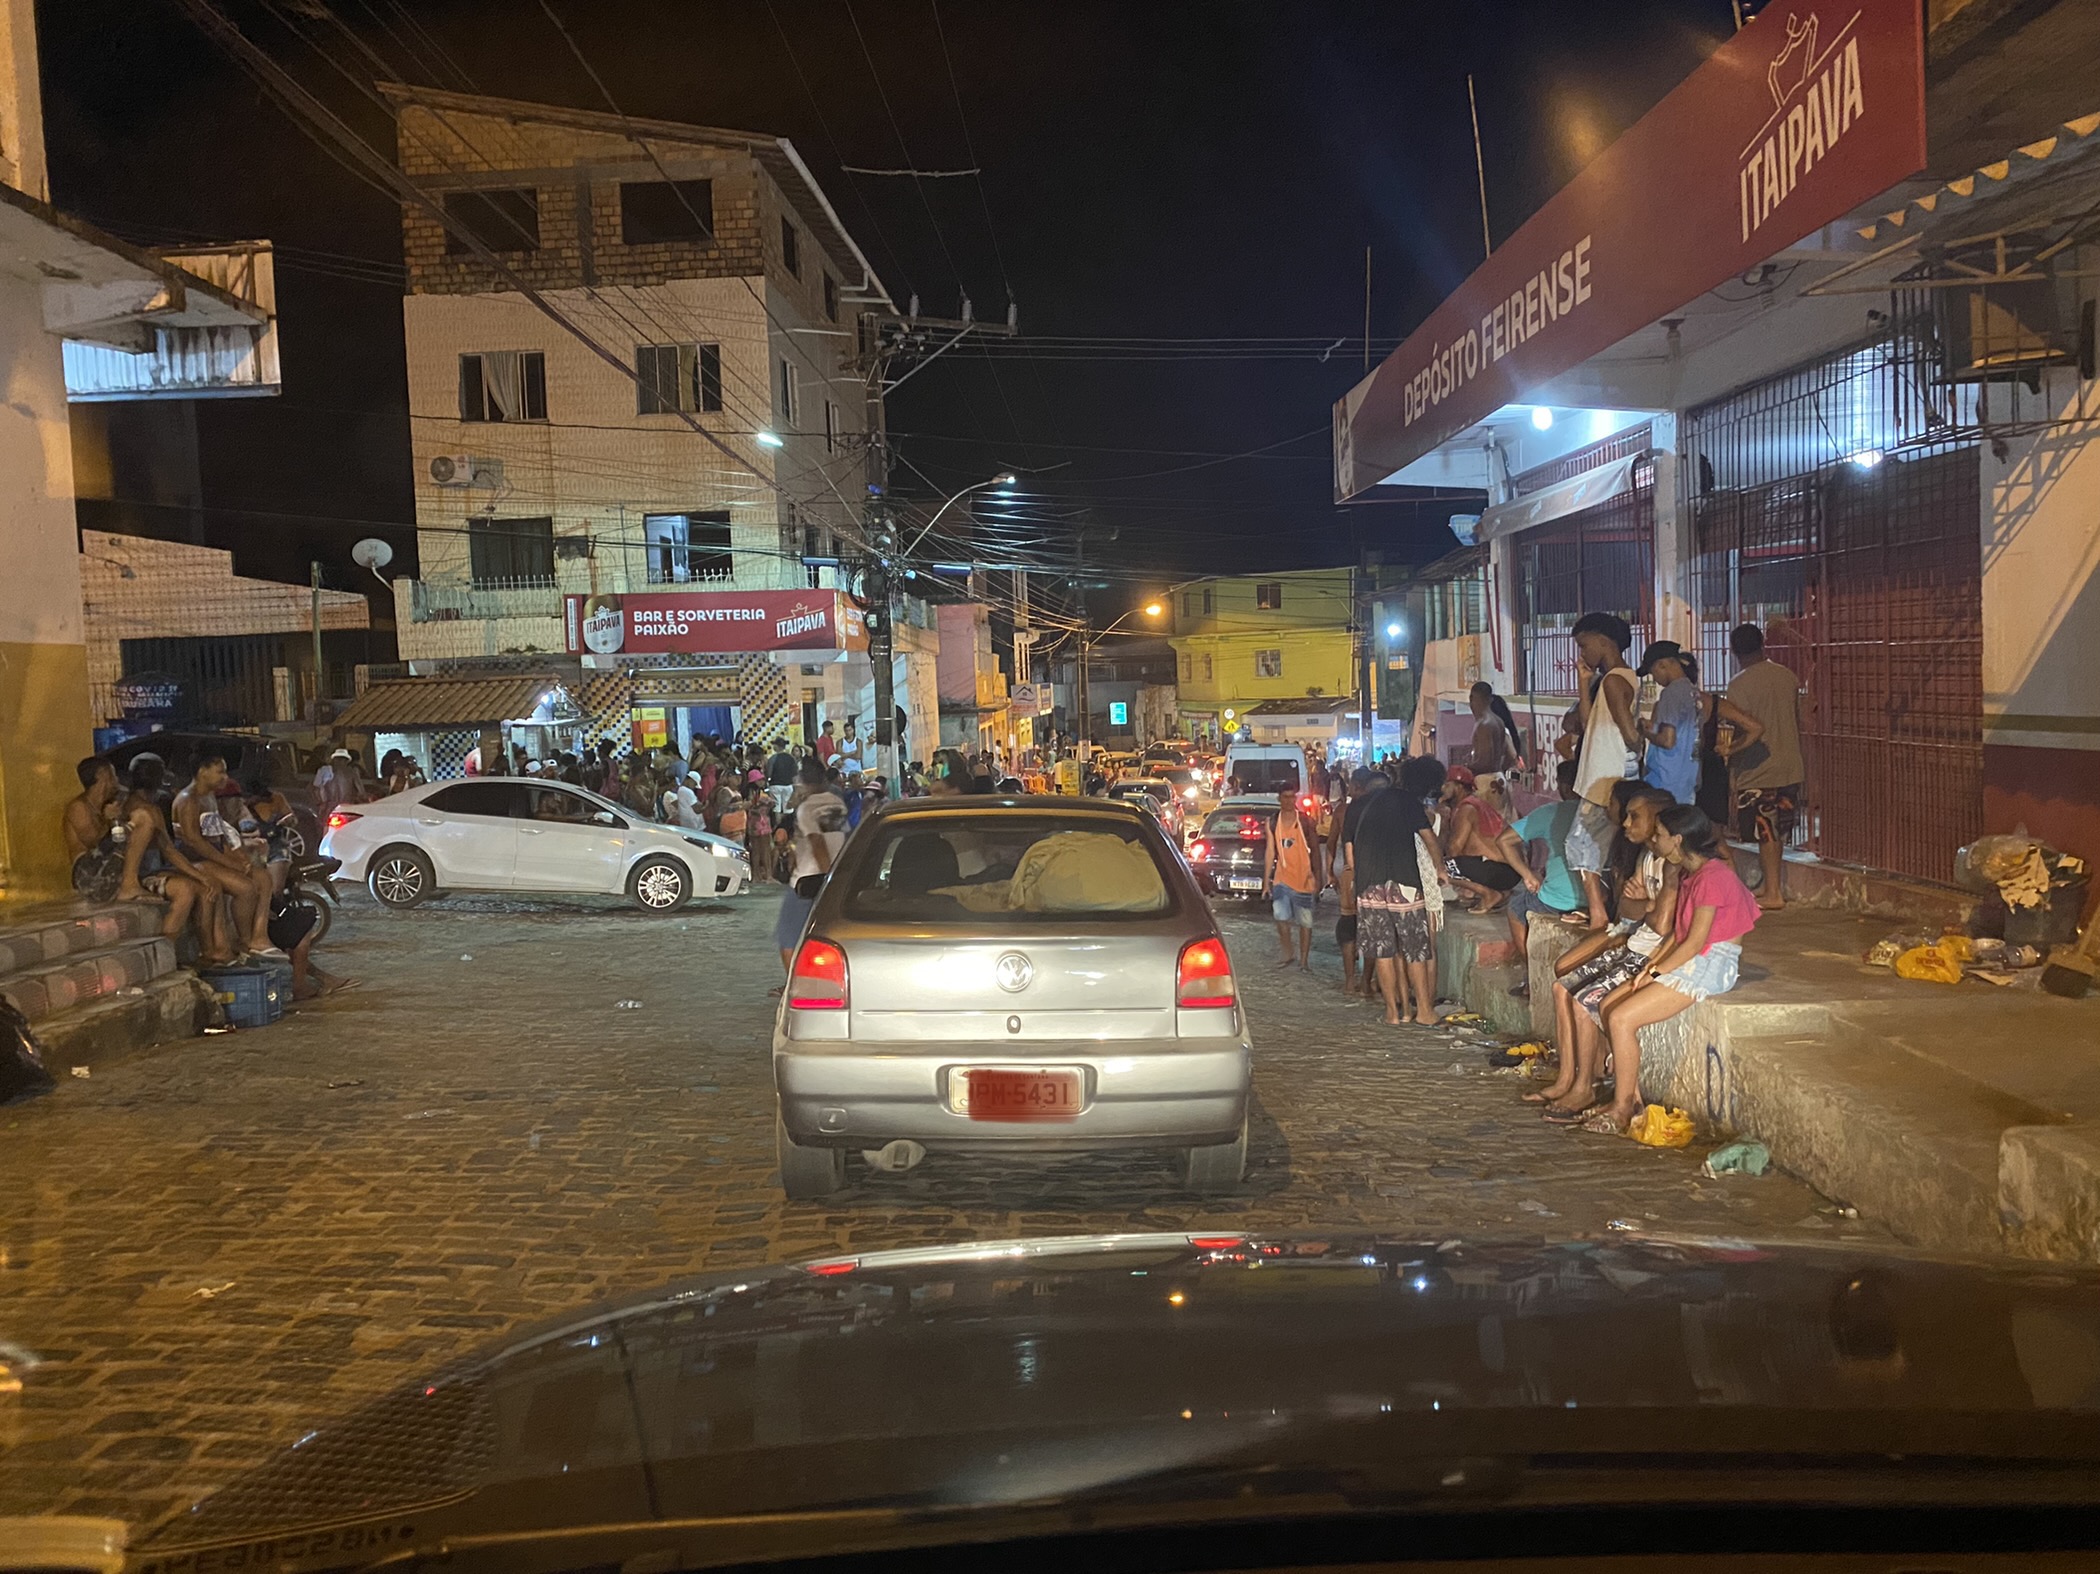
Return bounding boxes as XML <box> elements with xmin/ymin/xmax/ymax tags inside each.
<box><xmin>1583</xmin><ymin>804</ymin><xmax>1758</xmax><ymax>1135</ymax></box>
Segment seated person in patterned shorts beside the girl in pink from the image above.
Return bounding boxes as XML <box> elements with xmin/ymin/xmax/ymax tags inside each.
<box><xmin>1525</xmin><ymin>783</ymin><xmax>1676</xmax><ymax>1121</ymax></box>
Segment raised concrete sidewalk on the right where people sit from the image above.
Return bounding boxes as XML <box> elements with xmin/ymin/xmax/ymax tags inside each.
<box><xmin>1441</xmin><ymin>909</ymin><xmax>2100</xmax><ymax>1261</ymax></box>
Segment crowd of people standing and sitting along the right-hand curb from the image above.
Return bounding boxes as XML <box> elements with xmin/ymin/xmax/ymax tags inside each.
<box><xmin>1264</xmin><ymin>613</ymin><xmax>1806</xmax><ymax>1133</ymax></box>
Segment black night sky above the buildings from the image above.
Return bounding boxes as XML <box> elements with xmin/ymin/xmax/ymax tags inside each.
<box><xmin>38</xmin><ymin>0</ymin><xmax>1733</xmax><ymax>600</ymax></box>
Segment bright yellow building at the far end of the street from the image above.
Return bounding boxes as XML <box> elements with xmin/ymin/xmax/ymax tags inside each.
<box><xmin>1170</xmin><ymin>569</ymin><xmax>1357</xmax><ymax>741</ymax></box>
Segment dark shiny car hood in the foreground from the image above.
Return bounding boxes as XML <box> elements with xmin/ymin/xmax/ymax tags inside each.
<box><xmin>139</xmin><ymin>1234</ymin><xmax>2100</xmax><ymax>1570</ymax></box>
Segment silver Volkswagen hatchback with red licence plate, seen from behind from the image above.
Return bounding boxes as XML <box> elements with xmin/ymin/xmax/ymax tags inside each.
<box><xmin>773</xmin><ymin>797</ymin><xmax>1252</xmax><ymax>1198</ymax></box>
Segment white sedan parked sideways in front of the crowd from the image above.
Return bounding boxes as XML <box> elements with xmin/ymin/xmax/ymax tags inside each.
<box><xmin>321</xmin><ymin>777</ymin><xmax>752</xmax><ymax>913</ymax></box>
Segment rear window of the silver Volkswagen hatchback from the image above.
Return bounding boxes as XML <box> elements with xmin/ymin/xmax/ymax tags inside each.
<box><xmin>846</xmin><ymin>812</ymin><xmax>1176</xmax><ymax>926</ymax></box>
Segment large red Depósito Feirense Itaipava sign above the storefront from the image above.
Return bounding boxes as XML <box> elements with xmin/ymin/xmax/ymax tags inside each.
<box><xmin>1334</xmin><ymin>0</ymin><xmax>1926</xmax><ymax>499</ymax></box>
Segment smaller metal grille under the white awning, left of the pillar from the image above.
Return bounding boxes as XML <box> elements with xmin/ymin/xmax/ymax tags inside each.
<box><xmin>1512</xmin><ymin>426</ymin><xmax>1655</xmax><ymax>695</ymax></box>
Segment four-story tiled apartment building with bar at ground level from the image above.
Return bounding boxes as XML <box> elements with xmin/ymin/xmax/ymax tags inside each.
<box><xmin>384</xmin><ymin>86</ymin><xmax>937</xmax><ymax>770</ymax></box>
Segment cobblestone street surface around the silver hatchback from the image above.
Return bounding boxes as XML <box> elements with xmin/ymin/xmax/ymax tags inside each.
<box><xmin>0</xmin><ymin>890</ymin><xmax>1880</xmax><ymax>1524</ymax></box>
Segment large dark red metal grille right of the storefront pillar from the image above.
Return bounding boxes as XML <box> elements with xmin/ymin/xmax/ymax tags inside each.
<box><xmin>1686</xmin><ymin>315</ymin><xmax>1982</xmax><ymax>879</ymax></box>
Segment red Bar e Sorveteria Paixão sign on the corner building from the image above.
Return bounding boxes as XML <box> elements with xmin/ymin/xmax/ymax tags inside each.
<box><xmin>563</xmin><ymin>590</ymin><xmax>867</xmax><ymax>655</ymax></box>
